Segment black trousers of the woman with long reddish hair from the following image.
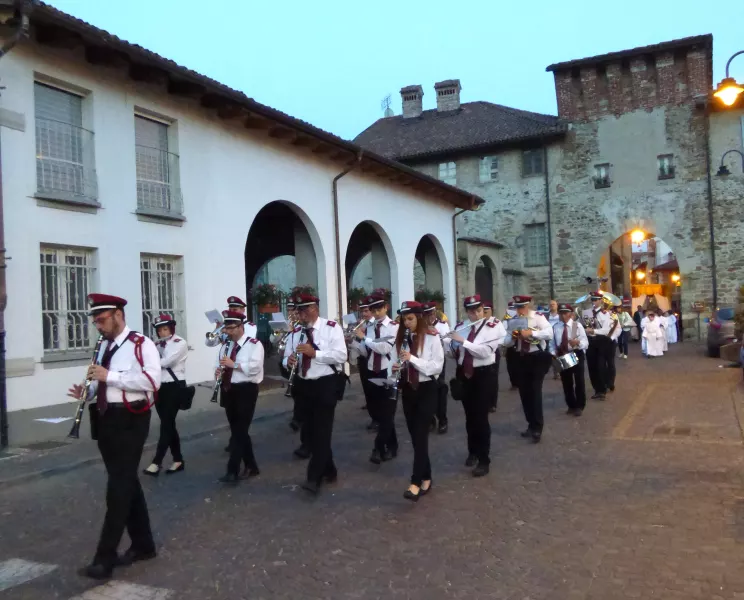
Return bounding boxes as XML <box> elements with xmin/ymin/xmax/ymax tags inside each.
<box><xmin>401</xmin><ymin>380</ymin><xmax>439</xmax><ymax>486</ymax></box>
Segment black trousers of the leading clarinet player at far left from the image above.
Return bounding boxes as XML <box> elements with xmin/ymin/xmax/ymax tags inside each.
<box><xmin>94</xmin><ymin>403</ymin><xmax>155</xmax><ymax>565</ymax></box>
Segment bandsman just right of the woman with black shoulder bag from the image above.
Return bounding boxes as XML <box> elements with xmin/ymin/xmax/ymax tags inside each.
<box><xmin>215</xmin><ymin>310</ymin><xmax>264</xmax><ymax>484</ymax></box>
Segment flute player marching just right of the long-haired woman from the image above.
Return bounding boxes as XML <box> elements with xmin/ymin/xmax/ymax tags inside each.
<box><xmin>445</xmin><ymin>294</ymin><xmax>506</xmax><ymax>477</ymax></box>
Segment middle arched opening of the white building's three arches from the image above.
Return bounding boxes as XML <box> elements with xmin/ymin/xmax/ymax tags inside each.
<box><xmin>345</xmin><ymin>221</ymin><xmax>395</xmax><ymax>308</ymax></box>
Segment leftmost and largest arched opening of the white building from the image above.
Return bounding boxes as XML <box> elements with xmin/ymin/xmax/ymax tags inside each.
<box><xmin>245</xmin><ymin>200</ymin><xmax>325</xmax><ymax>341</ymax></box>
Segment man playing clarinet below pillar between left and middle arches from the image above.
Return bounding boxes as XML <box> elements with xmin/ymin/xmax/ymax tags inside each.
<box><xmin>284</xmin><ymin>294</ymin><xmax>347</xmax><ymax>494</ymax></box>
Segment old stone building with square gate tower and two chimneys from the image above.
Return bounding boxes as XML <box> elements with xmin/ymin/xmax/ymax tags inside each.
<box><xmin>355</xmin><ymin>35</ymin><xmax>744</xmax><ymax>335</ymax></box>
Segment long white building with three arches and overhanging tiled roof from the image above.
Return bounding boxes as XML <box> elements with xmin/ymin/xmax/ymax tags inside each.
<box><xmin>0</xmin><ymin>3</ymin><xmax>482</xmax><ymax>418</ymax></box>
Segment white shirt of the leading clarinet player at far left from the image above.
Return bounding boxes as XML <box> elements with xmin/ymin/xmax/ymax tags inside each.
<box><xmin>88</xmin><ymin>326</ymin><xmax>161</xmax><ymax>404</ymax></box>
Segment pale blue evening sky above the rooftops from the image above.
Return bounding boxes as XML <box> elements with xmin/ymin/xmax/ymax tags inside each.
<box><xmin>47</xmin><ymin>0</ymin><xmax>744</xmax><ymax>138</ymax></box>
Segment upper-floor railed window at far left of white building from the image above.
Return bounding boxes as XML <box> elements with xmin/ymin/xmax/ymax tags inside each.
<box><xmin>36</xmin><ymin>119</ymin><xmax>98</xmax><ymax>203</ymax></box>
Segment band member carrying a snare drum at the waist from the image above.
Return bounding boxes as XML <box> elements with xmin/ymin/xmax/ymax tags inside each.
<box><xmin>550</xmin><ymin>304</ymin><xmax>589</xmax><ymax>417</ymax></box>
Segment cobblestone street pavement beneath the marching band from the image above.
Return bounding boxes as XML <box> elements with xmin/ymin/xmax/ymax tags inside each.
<box><xmin>0</xmin><ymin>344</ymin><xmax>744</xmax><ymax>600</ymax></box>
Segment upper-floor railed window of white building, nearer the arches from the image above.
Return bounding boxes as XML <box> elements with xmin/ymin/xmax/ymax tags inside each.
<box><xmin>135</xmin><ymin>145</ymin><xmax>183</xmax><ymax>216</ymax></box>
